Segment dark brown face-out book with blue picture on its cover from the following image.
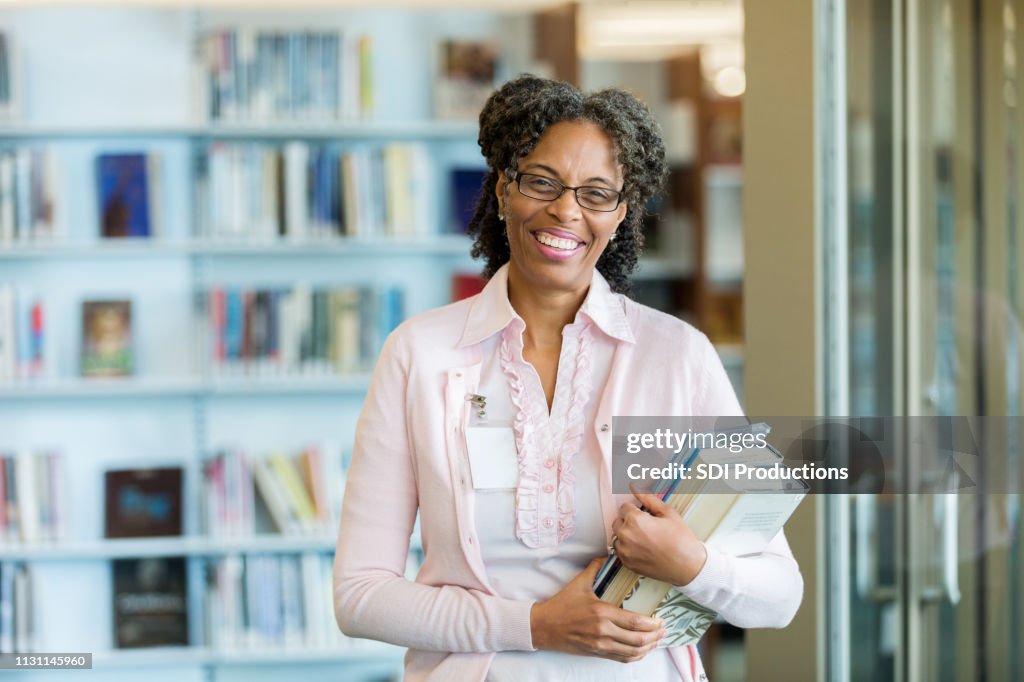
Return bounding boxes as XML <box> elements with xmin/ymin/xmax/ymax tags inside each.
<box><xmin>104</xmin><ymin>467</ymin><xmax>182</xmax><ymax>538</ymax></box>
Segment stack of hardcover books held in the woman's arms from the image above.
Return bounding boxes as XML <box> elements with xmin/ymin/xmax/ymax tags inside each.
<box><xmin>594</xmin><ymin>438</ymin><xmax>809</xmax><ymax>646</ymax></box>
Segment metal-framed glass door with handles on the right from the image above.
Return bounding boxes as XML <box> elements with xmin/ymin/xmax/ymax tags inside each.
<box><xmin>827</xmin><ymin>0</ymin><xmax>1024</xmax><ymax>680</ymax></box>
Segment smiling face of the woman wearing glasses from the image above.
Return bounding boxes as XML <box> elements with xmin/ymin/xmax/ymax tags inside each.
<box><xmin>495</xmin><ymin>121</ymin><xmax>626</xmax><ymax>292</ymax></box>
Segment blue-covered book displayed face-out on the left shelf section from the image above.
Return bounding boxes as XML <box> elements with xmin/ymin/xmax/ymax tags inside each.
<box><xmin>96</xmin><ymin>153</ymin><xmax>160</xmax><ymax>238</ymax></box>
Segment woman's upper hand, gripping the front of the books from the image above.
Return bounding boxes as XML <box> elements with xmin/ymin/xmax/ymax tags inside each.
<box><xmin>611</xmin><ymin>491</ymin><xmax>708</xmax><ymax>586</ymax></box>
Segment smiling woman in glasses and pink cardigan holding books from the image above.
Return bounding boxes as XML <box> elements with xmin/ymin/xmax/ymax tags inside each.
<box><xmin>335</xmin><ymin>76</ymin><xmax>803</xmax><ymax>682</ymax></box>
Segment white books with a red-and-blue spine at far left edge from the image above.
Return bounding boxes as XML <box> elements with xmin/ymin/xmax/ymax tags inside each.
<box><xmin>0</xmin><ymin>284</ymin><xmax>46</xmax><ymax>385</ymax></box>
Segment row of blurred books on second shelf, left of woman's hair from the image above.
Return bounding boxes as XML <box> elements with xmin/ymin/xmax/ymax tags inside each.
<box><xmin>197</xmin><ymin>141</ymin><xmax>433</xmax><ymax>242</ymax></box>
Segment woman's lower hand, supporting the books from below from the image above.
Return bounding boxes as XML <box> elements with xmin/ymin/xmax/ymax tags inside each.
<box><xmin>529</xmin><ymin>559</ymin><xmax>666</xmax><ymax>663</ymax></box>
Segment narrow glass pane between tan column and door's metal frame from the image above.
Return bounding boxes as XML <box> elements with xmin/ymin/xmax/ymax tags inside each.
<box><xmin>843</xmin><ymin>0</ymin><xmax>899</xmax><ymax>681</ymax></box>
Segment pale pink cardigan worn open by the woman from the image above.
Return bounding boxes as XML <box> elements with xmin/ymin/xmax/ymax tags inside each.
<box><xmin>334</xmin><ymin>265</ymin><xmax>803</xmax><ymax>682</ymax></box>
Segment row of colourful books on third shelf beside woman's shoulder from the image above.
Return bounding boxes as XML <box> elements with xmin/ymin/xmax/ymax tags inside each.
<box><xmin>209</xmin><ymin>286</ymin><xmax>403</xmax><ymax>376</ymax></box>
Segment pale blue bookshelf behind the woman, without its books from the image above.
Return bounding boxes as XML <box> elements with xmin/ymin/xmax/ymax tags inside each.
<box><xmin>0</xmin><ymin>6</ymin><xmax>720</xmax><ymax>682</ymax></box>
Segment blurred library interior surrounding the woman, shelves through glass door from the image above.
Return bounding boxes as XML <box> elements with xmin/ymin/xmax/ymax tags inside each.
<box><xmin>6</xmin><ymin>0</ymin><xmax>1024</xmax><ymax>682</ymax></box>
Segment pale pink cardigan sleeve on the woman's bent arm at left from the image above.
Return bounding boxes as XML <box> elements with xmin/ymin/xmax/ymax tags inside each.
<box><xmin>334</xmin><ymin>330</ymin><xmax>534</xmax><ymax>652</ymax></box>
